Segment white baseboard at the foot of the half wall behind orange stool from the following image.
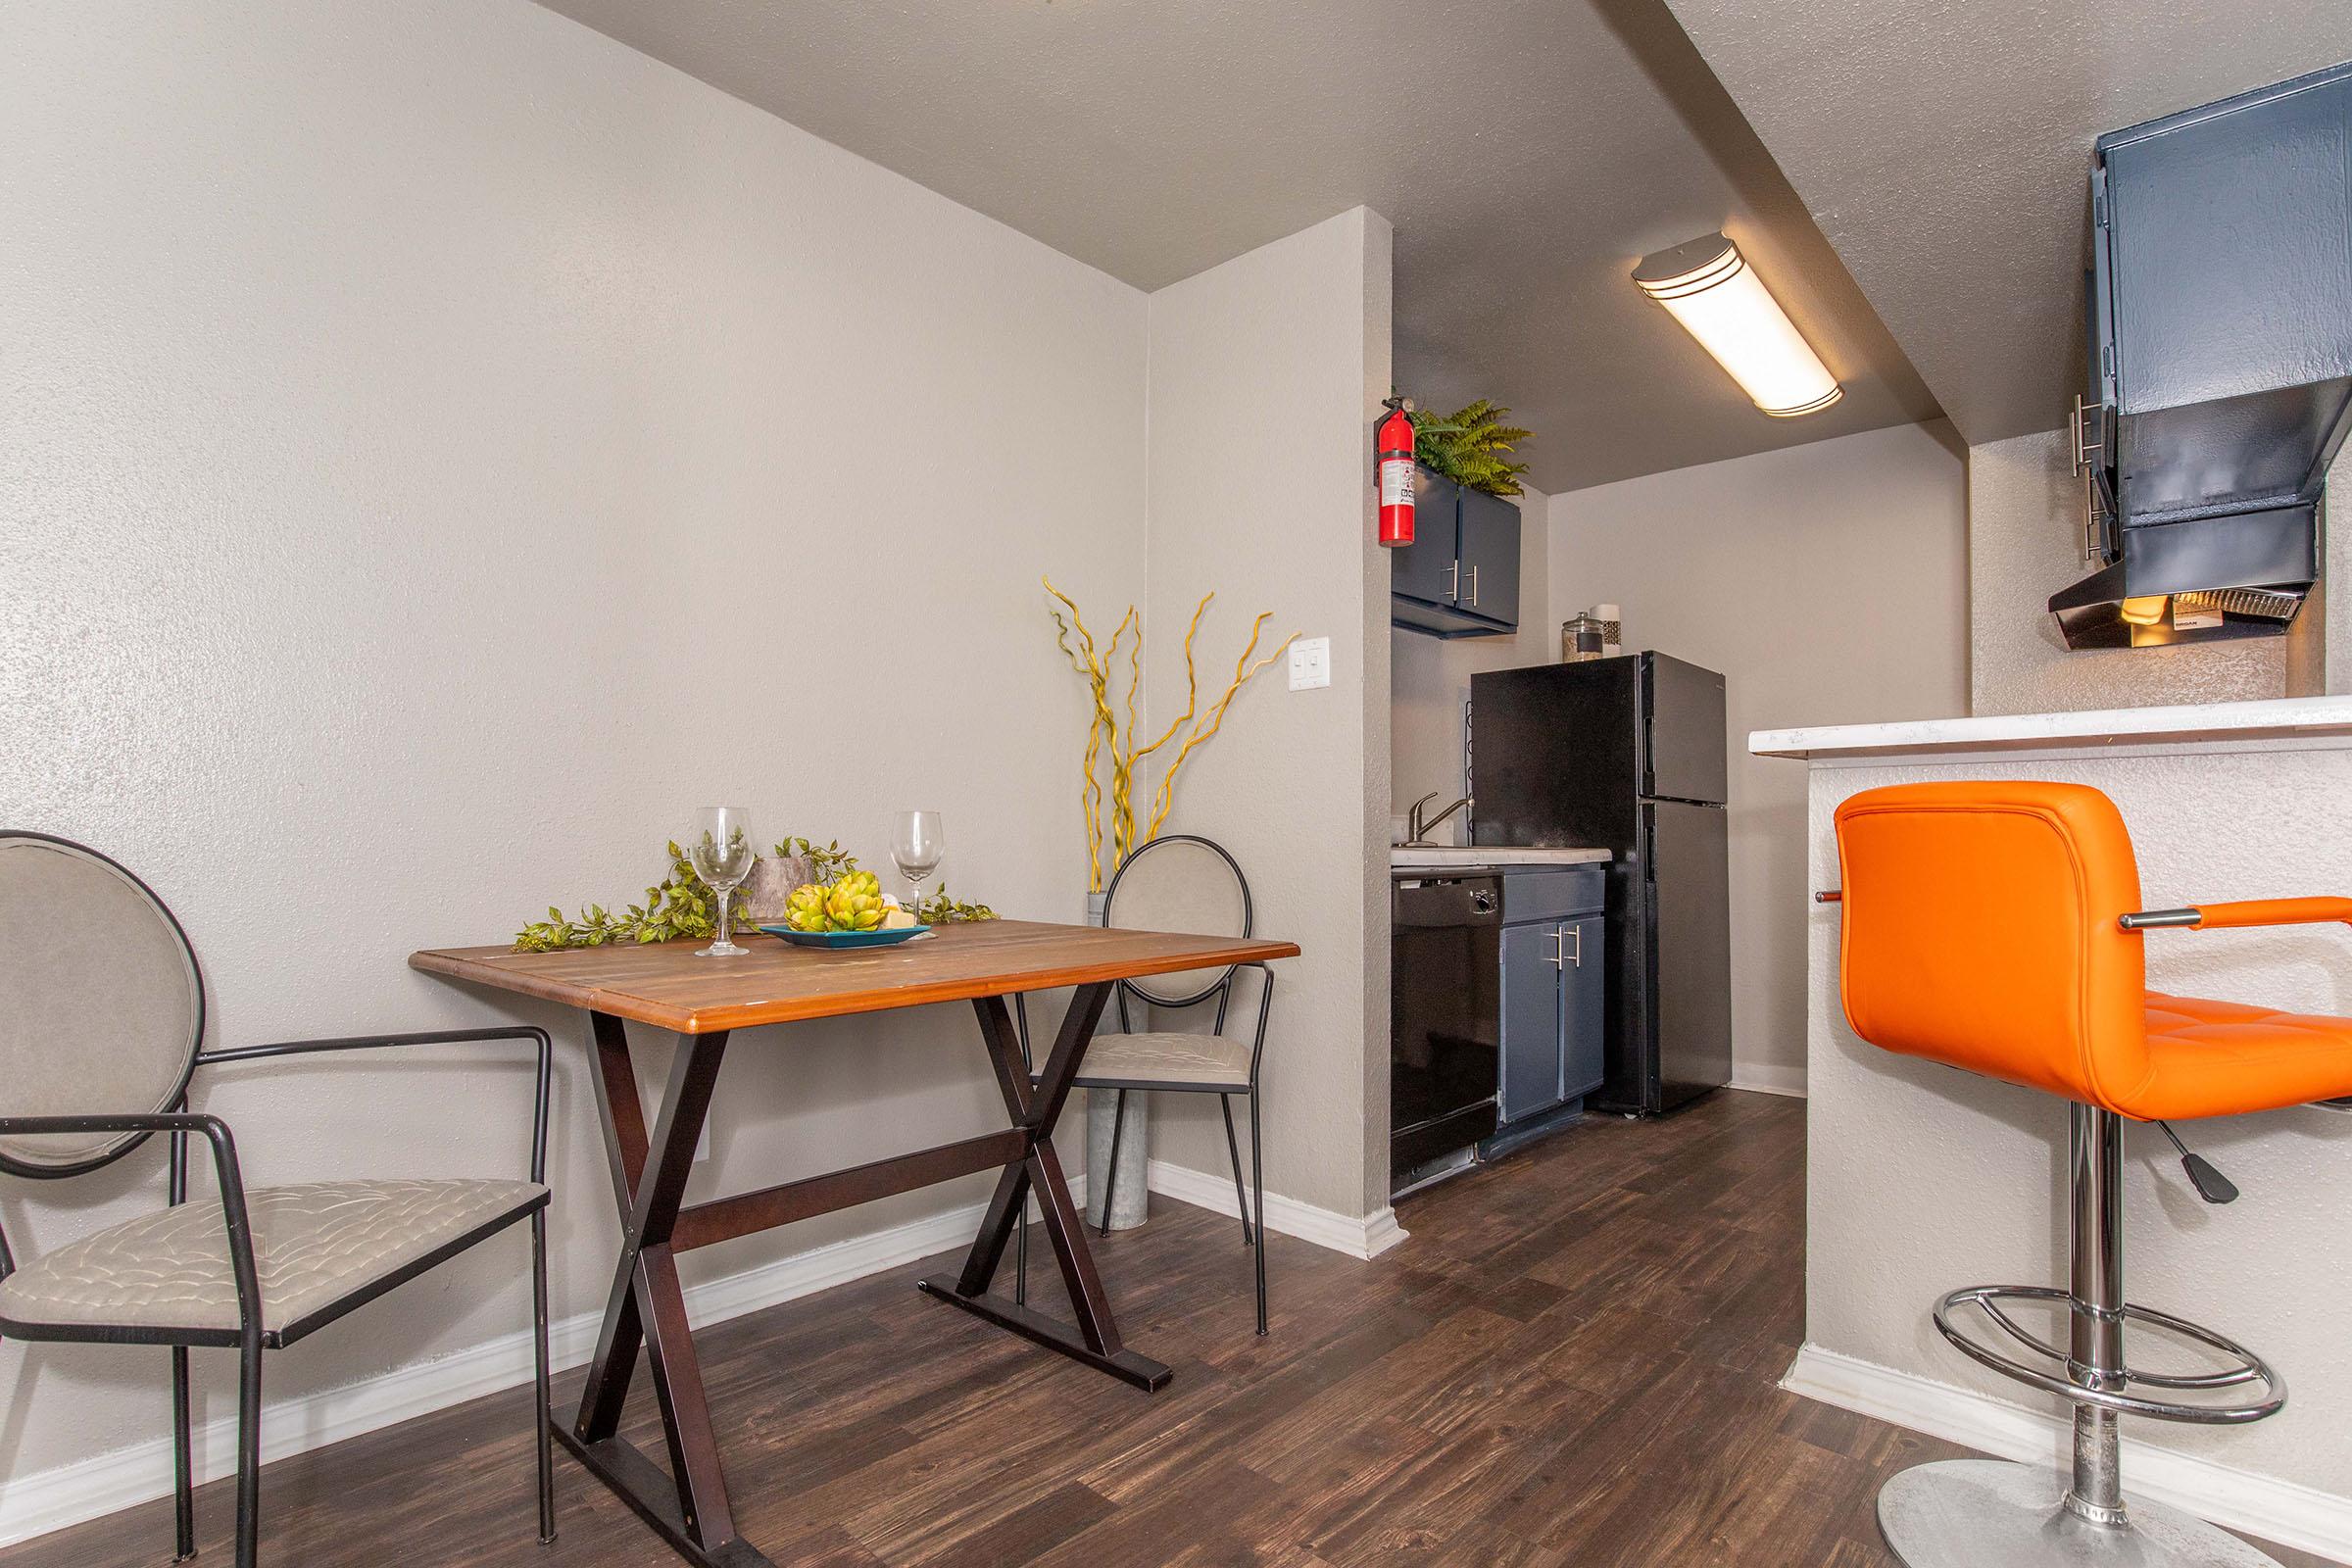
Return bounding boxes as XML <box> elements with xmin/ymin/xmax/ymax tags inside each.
<box><xmin>1781</xmin><ymin>1345</ymin><xmax>2352</xmax><ymax>1563</ymax></box>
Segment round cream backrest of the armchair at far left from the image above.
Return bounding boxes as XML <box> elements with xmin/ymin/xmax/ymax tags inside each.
<box><xmin>0</xmin><ymin>832</ymin><xmax>205</xmax><ymax>1175</ymax></box>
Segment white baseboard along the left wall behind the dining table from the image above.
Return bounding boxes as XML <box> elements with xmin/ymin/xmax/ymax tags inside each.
<box><xmin>0</xmin><ymin>1173</ymin><xmax>1087</xmax><ymax>1546</ymax></box>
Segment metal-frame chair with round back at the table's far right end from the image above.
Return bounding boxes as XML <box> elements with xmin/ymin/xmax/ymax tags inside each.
<box><xmin>1021</xmin><ymin>832</ymin><xmax>1275</xmax><ymax>1333</ymax></box>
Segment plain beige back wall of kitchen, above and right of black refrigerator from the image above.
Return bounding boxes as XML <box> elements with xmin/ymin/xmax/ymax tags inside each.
<box><xmin>1552</xmin><ymin>425</ymin><xmax>1969</xmax><ymax>1089</ymax></box>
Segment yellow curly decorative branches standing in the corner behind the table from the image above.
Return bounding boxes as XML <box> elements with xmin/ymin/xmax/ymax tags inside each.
<box><xmin>1049</xmin><ymin>578</ymin><xmax>1298</xmax><ymax>894</ymax></box>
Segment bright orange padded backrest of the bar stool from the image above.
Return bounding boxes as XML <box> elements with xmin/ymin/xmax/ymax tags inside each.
<box><xmin>1837</xmin><ymin>780</ymin><xmax>2150</xmax><ymax>1109</ymax></box>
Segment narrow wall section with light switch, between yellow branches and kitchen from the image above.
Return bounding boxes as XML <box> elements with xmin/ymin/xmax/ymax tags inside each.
<box><xmin>1146</xmin><ymin>207</ymin><xmax>1390</xmax><ymax>1218</ymax></box>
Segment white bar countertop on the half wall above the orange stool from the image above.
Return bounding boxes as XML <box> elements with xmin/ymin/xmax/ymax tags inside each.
<box><xmin>1747</xmin><ymin>696</ymin><xmax>2352</xmax><ymax>761</ymax></box>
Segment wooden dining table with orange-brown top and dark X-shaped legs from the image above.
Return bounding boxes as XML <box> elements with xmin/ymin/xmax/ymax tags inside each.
<box><xmin>410</xmin><ymin>919</ymin><xmax>1298</xmax><ymax>1568</ymax></box>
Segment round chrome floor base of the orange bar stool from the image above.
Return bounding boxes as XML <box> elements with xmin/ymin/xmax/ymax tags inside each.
<box><xmin>1880</xmin><ymin>1460</ymin><xmax>2279</xmax><ymax>1568</ymax></box>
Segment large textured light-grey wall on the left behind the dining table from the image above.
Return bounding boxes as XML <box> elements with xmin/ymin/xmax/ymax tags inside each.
<box><xmin>0</xmin><ymin>0</ymin><xmax>1138</xmax><ymax>1481</ymax></box>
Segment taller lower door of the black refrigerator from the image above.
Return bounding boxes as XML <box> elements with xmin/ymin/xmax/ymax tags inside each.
<box><xmin>1644</xmin><ymin>802</ymin><xmax>1731</xmax><ymax>1109</ymax></box>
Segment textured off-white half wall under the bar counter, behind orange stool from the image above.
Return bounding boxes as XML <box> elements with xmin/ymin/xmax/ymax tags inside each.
<box><xmin>1806</xmin><ymin>750</ymin><xmax>2352</xmax><ymax>1497</ymax></box>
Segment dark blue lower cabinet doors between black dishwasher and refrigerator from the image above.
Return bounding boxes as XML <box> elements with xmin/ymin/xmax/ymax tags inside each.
<box><xmin>1503</xmin><ymin>914</ymin><xmax>1609</xmax><ymax>1126</ymax></box>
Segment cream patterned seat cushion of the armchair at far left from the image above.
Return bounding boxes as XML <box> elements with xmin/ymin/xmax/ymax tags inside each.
<box><xmin>0</xmin><ymin>1180</ymin><xmax>548</xmax><ymax>1333</ymax></box>
